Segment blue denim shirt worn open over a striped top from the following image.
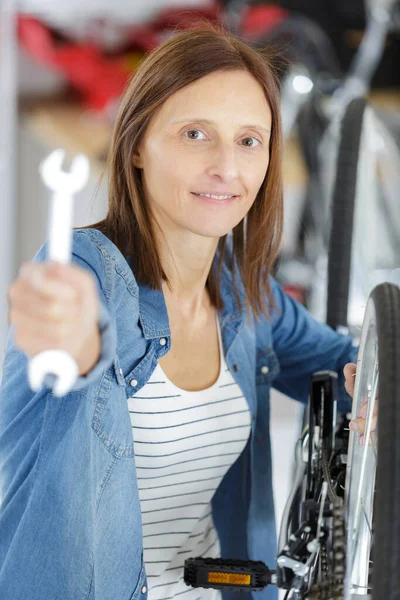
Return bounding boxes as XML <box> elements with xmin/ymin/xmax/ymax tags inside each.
<box><xmin>0</xmin><ymin>228</ymin><xmax>357</xmax><ymax>600</ymax></box>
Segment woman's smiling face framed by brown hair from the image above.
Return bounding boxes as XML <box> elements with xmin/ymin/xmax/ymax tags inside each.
<box><xmin>133</xmin><ymin>71</ymin><xmax>271</xmax><ymax>238</ymax></box>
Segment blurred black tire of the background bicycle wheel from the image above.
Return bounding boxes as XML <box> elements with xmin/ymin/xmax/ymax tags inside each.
<box><xmin>326</xmin><ymin>98</ymin><xmax>366</xmax><ymax>330</ymax></box>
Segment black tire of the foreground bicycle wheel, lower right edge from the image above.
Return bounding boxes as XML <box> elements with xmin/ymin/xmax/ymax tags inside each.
<box><xmin>345</xmin><ymin>283</ymin><xmax>400</xmax><ymax>600</ymax></box>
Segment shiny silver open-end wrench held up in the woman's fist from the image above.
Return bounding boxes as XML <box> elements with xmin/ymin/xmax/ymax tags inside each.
<box><xmin>28</xmin><ymin>149</ymin><xmax>90</xmax><ymax>397</ymax></box>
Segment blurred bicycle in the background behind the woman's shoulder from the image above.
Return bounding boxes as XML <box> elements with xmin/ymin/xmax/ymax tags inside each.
<box><xmin>288</xmin><ymin>1</ymin><xmax>400</xmax><ymax>332</ymax></box>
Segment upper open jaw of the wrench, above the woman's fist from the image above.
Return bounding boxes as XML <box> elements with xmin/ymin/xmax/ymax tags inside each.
<box><xmin>39</xmin><ymin>148</ymin><xmax>90</xmax><ymax>194</ymax></box>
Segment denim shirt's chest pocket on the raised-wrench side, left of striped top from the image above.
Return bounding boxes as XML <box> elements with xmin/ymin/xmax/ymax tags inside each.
<box><xmin>91</xmin><ymin>355</ymin><xmax>134</xmax><ymax>458</ymax></box>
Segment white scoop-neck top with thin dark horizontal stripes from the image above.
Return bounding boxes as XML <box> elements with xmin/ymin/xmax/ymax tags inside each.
<box><xmin>128</xmin><ymin>320</ymin><xmax>251</xmax><ymax>600</ymax></box>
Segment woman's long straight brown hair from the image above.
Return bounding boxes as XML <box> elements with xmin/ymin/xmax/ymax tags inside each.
<box><xmin>79</xmin><ymin>23</ymin><xmax>283</xmax><ymax>320</ymax></box>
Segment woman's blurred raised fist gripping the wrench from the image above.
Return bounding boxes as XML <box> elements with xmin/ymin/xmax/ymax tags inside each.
<box><xmin>7</xmin><ymin>262</ymin><xmax>100</xmax><ymax>375</ymax></box>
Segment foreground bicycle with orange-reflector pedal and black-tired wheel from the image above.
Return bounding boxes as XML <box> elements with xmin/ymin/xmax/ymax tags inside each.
<box><xmin>184</xmin><ymin>282</ymin><xmax>400</xmax><ymax>600</ymax></box>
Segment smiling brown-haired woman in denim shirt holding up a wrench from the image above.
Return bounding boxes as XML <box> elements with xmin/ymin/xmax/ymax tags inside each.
<box><xmin>0</xmin><ymin>26</ymin><xmax>357</xmax><ymax>600</ymax></box>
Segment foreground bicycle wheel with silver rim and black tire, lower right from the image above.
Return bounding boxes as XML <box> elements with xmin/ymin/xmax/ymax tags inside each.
<box><xmin>344</xmin><ymin>283</ymin><xmax>400</xmax><ymax>600</ymax></box>
